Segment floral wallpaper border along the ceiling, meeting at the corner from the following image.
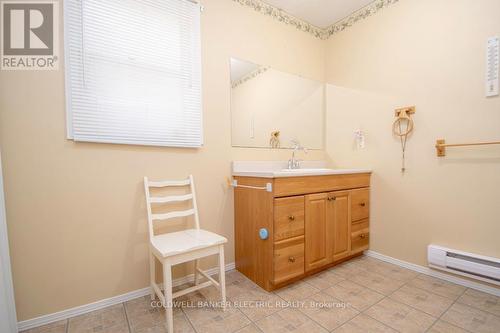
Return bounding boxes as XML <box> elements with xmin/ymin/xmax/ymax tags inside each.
<box><xmin>233</xmin><ymin>0</ymin><xmax>399</xmax><ymax>39</ymax></box>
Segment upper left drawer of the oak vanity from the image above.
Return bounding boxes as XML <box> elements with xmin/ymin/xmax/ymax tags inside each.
<box><xmin>274</xmin><ymin>196</ymin><xmax>304</xmax><ymax>241</ymax></box>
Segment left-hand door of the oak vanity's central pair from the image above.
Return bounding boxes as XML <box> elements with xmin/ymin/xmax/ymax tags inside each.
<box><xmin>305</xmin><ymin>193</ymin><xmax>332</xmax><ymax>271</ymax></box>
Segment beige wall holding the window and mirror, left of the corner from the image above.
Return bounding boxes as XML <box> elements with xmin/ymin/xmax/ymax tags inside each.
<box><xmin>0</xmin><ymin>0</ymin><xmax>325</xmax><ymax>320</ymax></box>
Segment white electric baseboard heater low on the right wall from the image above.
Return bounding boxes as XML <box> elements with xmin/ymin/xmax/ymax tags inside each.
<box><xmin>427</xmin><ymin>244</ymin><xmax>500</xmax><ymax>285</ymax></box>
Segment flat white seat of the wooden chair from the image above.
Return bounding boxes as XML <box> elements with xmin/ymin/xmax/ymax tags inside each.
<box><xmin>151</xmin><ymin>229</ymin><xmax>227</xmax><ymax>257</ymax></box>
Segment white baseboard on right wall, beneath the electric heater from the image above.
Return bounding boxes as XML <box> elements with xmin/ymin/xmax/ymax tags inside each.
<box><xmin>365</xmin><ymin>250</ymin><xmax>500</xmax><ymax>296</ymax></box>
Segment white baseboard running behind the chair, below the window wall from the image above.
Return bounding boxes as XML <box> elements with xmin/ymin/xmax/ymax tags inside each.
<box><xmin>17</xmin><ymin>262</ymin><xmax>235</xmax><ymax>331</ymax></box>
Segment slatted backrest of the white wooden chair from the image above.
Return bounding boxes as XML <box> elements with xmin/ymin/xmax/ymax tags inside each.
<box><xmin>144</xmin><ymin>175</ymin><xmax>200</xmax><ymax>239</ymax></box>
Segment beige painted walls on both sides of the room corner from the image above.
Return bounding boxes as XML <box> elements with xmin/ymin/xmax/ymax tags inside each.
<box><xmin>0</xmin><ymin>0</ymin><xmax>500</xmax><ymax>320</ymax></box>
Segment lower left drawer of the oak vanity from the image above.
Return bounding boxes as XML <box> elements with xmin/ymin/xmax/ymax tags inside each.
<box><xmin>274</xmin><ymin>236</ymin><xmax>304</xmax><ymax>284</ymax></box>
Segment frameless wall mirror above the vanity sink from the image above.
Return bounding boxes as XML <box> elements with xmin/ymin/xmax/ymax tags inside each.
<box><xmin>231</xmin><ymin>58</ymin><xmax>325</xmax><ymax>149</ymax></box>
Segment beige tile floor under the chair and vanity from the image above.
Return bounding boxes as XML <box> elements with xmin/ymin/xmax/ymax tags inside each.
<box><xmin>26</xmin><ymin>257</ymin><xmax>500</xmax><ymax>333</ymax></box>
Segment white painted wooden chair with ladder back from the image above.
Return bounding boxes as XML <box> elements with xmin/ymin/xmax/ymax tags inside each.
<box><xmin>144</xmin><ymin>175</ymin><xmax>227</xmax><ymax>333</ymax></box>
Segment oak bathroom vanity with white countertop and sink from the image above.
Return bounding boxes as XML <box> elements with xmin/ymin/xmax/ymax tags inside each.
<box><xmin>232</xmin><ymin>162</ymin><xmax>371</xmax><ymax>291</ymax></box>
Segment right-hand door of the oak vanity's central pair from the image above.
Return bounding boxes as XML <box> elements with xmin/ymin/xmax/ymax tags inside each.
<box><xmin>329</xmin><ymin>191</ymin><xmax>351</xmax><ymax>261</ymax></box>
